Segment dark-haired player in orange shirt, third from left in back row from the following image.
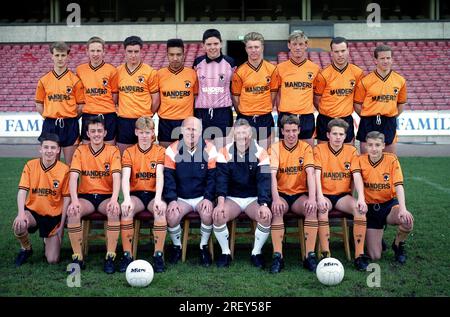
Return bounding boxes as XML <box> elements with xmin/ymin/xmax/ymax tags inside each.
<box><xmin>117</xmin><ymin>36</ymin><xmax>159</xmax><ymax>153</ymax></box>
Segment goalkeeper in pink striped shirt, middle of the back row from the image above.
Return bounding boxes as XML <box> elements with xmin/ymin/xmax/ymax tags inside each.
<box><xmin>194</xmin><ymin>29</ymin><xmax>236</xmax><ymax>148</ymax></box>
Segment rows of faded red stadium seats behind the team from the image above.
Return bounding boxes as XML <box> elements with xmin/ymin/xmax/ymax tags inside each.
<box><xmin>0</xmin><ymin>41</ymin><xmax>450</xmax><ymax>112</ymax></box>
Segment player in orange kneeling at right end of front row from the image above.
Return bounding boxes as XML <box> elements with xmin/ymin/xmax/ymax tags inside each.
<box><xmin>359</xmin><ymin>131</ymin><xmax>414</xmax><ymax>264</ymax></box>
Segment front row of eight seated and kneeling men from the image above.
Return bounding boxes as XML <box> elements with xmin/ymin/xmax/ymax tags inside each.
<box><xmin>13</xmin><ymin>116</ymin><xmax>413</xmax><ymax>273</ymax></box>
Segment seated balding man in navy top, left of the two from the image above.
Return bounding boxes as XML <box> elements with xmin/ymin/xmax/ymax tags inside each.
<box><xmin>163</xmin><ymin>117</ymin><xmax>217</xmax><ymax>266</ymax></box>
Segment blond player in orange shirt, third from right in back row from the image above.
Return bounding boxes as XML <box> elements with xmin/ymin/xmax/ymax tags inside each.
<box><xmin>275</xmin><ymin>30</ymin><xmax>320</xmax><ymax>146</ymax></box>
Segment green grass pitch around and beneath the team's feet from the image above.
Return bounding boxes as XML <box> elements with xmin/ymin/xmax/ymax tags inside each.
<box><xmin>0</xmin><ymin>158</ymin><xmax>450</xmax><ymax>297</ymax></box>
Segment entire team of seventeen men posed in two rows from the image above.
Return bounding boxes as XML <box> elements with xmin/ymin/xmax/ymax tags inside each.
<box><xmin>14</xmin><ymin>29</ymin><xmax>413</xmax><ymax>273</ymax></box>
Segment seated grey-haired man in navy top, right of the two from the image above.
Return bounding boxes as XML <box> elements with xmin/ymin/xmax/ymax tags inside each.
<box><xmin>213</xmin><ymin>119</ymin><xmax>272</xmax><ymax>268</ymax></box>
